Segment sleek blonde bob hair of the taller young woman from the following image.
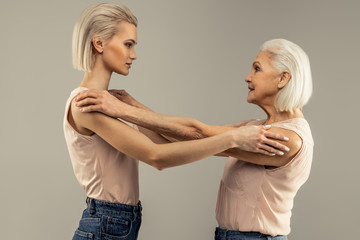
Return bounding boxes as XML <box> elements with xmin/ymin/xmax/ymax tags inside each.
<box><xmin>72</xmin><ymin>3</ymin><xmax>138</xmax><ymax>72</ymax></box>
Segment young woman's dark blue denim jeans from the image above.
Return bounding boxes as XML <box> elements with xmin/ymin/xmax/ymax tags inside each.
<box><xmin>73</xmin><ymin>198</ymin><xmax>142</xmax><ymax>240</ymax></box>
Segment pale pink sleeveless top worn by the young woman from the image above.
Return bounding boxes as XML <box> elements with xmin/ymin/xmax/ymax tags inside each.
<box><xmin>63</xmin><ymin>87</ymin><xmax>139</xmax><ymax>205</ymax></box>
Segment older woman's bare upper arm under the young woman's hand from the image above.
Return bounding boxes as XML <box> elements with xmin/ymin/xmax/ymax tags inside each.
<box><xmin>224</xmin><ymin>127</ymin><xmax>302</xmax><ymax>167</ymax></box>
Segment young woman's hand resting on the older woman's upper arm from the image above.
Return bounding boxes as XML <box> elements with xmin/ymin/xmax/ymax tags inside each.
<box><xmin>234</xmin><ymin>125</ymin><xmax>290</xmax><ymax>156</ymax></box>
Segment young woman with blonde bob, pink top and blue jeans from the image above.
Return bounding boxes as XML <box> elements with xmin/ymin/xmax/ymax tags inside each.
<box><xmin>64</xmin><ymin>3</ymin><xmax>286</xmax><ymax>240</ymax></box>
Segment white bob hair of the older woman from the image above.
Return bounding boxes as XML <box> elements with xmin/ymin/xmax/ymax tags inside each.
<box><xmin>260</xmin><ymin>39</ymin><xmax>312</xmax><ymax>112</ymax></box>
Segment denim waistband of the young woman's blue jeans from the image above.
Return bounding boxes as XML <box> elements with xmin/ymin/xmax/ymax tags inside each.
<box><xmin>86</xmin><ymin>197</ymin><xmax>142</xmax><ymax>217</ymax></box>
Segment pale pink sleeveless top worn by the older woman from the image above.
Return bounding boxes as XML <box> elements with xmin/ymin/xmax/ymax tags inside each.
<box><xmin>216</xmin><ymin>118</ymin><xmax>314</xmax><ymax>236</ymax></box>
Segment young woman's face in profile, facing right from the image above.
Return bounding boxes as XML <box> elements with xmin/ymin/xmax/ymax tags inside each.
<box><xmin>102</xmin><ymin>21</ymin><xmax>137</xmax><ymax>76</ymax></box>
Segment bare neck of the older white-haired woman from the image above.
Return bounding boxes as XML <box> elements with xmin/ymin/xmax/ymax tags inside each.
<box><xmin>260</xmin><ymin>106</ymin><xmax>304</xmax><ymax>124</ymax></box>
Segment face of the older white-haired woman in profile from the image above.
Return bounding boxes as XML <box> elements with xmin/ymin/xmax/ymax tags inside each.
<box><xmin>245</xmin><ymin>51</ymin><xmax>281</xmax><ymax>105</ymax></box>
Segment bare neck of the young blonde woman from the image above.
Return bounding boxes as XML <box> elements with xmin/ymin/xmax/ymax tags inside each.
<box><xmin>80</xmin><ymin>56</ymin><xmax>112</xmax><ymax>90</ymax></box>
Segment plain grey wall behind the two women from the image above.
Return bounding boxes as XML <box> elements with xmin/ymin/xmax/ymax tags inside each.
<box><xmin>0</xmin><ymin>0</ymin><xmax>360</xmax><ymax>240</ymax></box>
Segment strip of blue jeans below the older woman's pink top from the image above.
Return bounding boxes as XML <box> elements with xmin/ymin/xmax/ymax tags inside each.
<box><xmin>215</xmin><ymin>228</ymin><xmax>287</xmax><ymax>240</ymax></box>
